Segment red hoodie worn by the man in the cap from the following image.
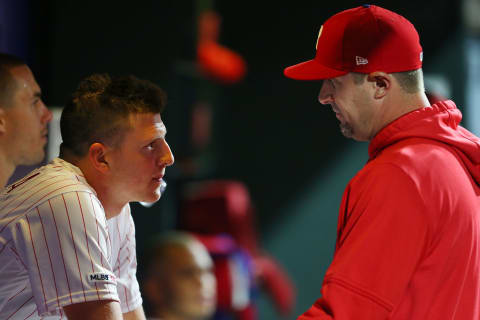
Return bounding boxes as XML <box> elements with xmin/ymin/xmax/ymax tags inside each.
<box><xmin>298</xmin><ymin>101</ymin><xmax>480</xmax><ymax>320</ymax></box>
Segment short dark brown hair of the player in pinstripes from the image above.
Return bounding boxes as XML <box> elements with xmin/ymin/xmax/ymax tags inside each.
<box><xmin>60</xmin><ymin>74</ymin><xmax>167</xmax><ymax>157</ymax></box>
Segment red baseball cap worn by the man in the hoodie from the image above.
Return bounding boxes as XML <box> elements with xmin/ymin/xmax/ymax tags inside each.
<box><xmin>284</xmin><ymin>5</ymin><xmax>423</xmax><ymax>80</ymax></box>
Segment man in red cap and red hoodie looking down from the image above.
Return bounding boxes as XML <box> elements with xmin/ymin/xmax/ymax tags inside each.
<box><xmin>285</xmin><ymin>5</ymin><xmax>480</xmax><ymax>320</ymax></box>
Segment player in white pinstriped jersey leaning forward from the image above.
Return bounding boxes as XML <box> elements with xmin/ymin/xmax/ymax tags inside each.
<box><xmin>0</xmin><ymin>74</ymin><xmax>174</xmax><ymax>319</ymax></box>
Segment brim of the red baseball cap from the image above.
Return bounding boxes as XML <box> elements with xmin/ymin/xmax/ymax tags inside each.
<box><xmin>283</xmin><ymin>59</ymin><xmax>348</xmax><ymax>80</ymax></box>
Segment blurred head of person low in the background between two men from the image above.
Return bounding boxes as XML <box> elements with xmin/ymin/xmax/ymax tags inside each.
<box><xmin>143</xmin><ymin>231</ymin><xmax>216</xmax><ymax>320</ymax></box>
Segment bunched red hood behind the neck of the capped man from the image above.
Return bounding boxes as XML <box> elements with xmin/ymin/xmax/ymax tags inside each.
<box><xmin>368</xmin><ymin>100</ymin><xmax>480</xmax><ymax>184</ymax></box>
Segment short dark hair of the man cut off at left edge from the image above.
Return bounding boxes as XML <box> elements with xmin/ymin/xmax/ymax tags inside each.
<box><xmin>0</xmin><ymin>53</ymin><xmax>26</xmax><ymax>108</ymax></box>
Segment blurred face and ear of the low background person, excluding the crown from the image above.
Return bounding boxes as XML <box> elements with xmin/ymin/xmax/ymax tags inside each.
<box><xmin>146</xmin><ymin>242</ymin><xmax>216</xmax><ymax>320</ymax></box>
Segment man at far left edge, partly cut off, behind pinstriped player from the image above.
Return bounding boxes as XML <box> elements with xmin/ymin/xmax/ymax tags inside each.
<box><xmin>0</xmin><ymin>53</ymin><xmax>52</xmax><ymax>187</ymax></box>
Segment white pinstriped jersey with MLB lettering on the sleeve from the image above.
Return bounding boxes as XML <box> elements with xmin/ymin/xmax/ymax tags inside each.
<box><xmin>0</xmin><ymin>158</ymin><xmax>142</xmax><ymax>320</ymax></box>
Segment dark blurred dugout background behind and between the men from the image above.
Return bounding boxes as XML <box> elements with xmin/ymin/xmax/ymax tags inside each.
<box><xmin>0</xmin><ymin>0</ymin><xmax>468</xmax><ymax>320</ymax></box>
